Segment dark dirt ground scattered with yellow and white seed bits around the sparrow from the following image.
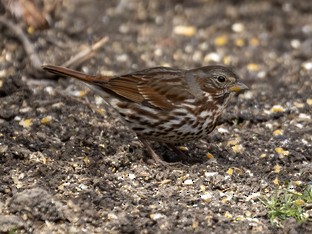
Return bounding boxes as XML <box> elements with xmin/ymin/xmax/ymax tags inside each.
<box><xmin>0</xmin><ymin>0</ymin><xmax>312</xmax><ymax>233</ymax></box>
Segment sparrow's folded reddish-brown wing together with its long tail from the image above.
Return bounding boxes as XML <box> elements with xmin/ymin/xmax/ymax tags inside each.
<box><xmin>43</xmin><ymin>65</ymin><xmax>193</xmax><ymax>110</ymax></box>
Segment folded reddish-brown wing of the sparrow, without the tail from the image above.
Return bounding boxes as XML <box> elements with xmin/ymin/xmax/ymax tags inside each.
<box><xmin>104</xmin><ymin>67</ymin><xmax>192</xmax><ymax>110</ymax></box>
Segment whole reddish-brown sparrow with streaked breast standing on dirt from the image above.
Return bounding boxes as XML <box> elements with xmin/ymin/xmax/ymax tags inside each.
<box><xmin>43</xmin><ymin>65</ymin><xmax>248</xmax><ymax>164</ymax></box>
